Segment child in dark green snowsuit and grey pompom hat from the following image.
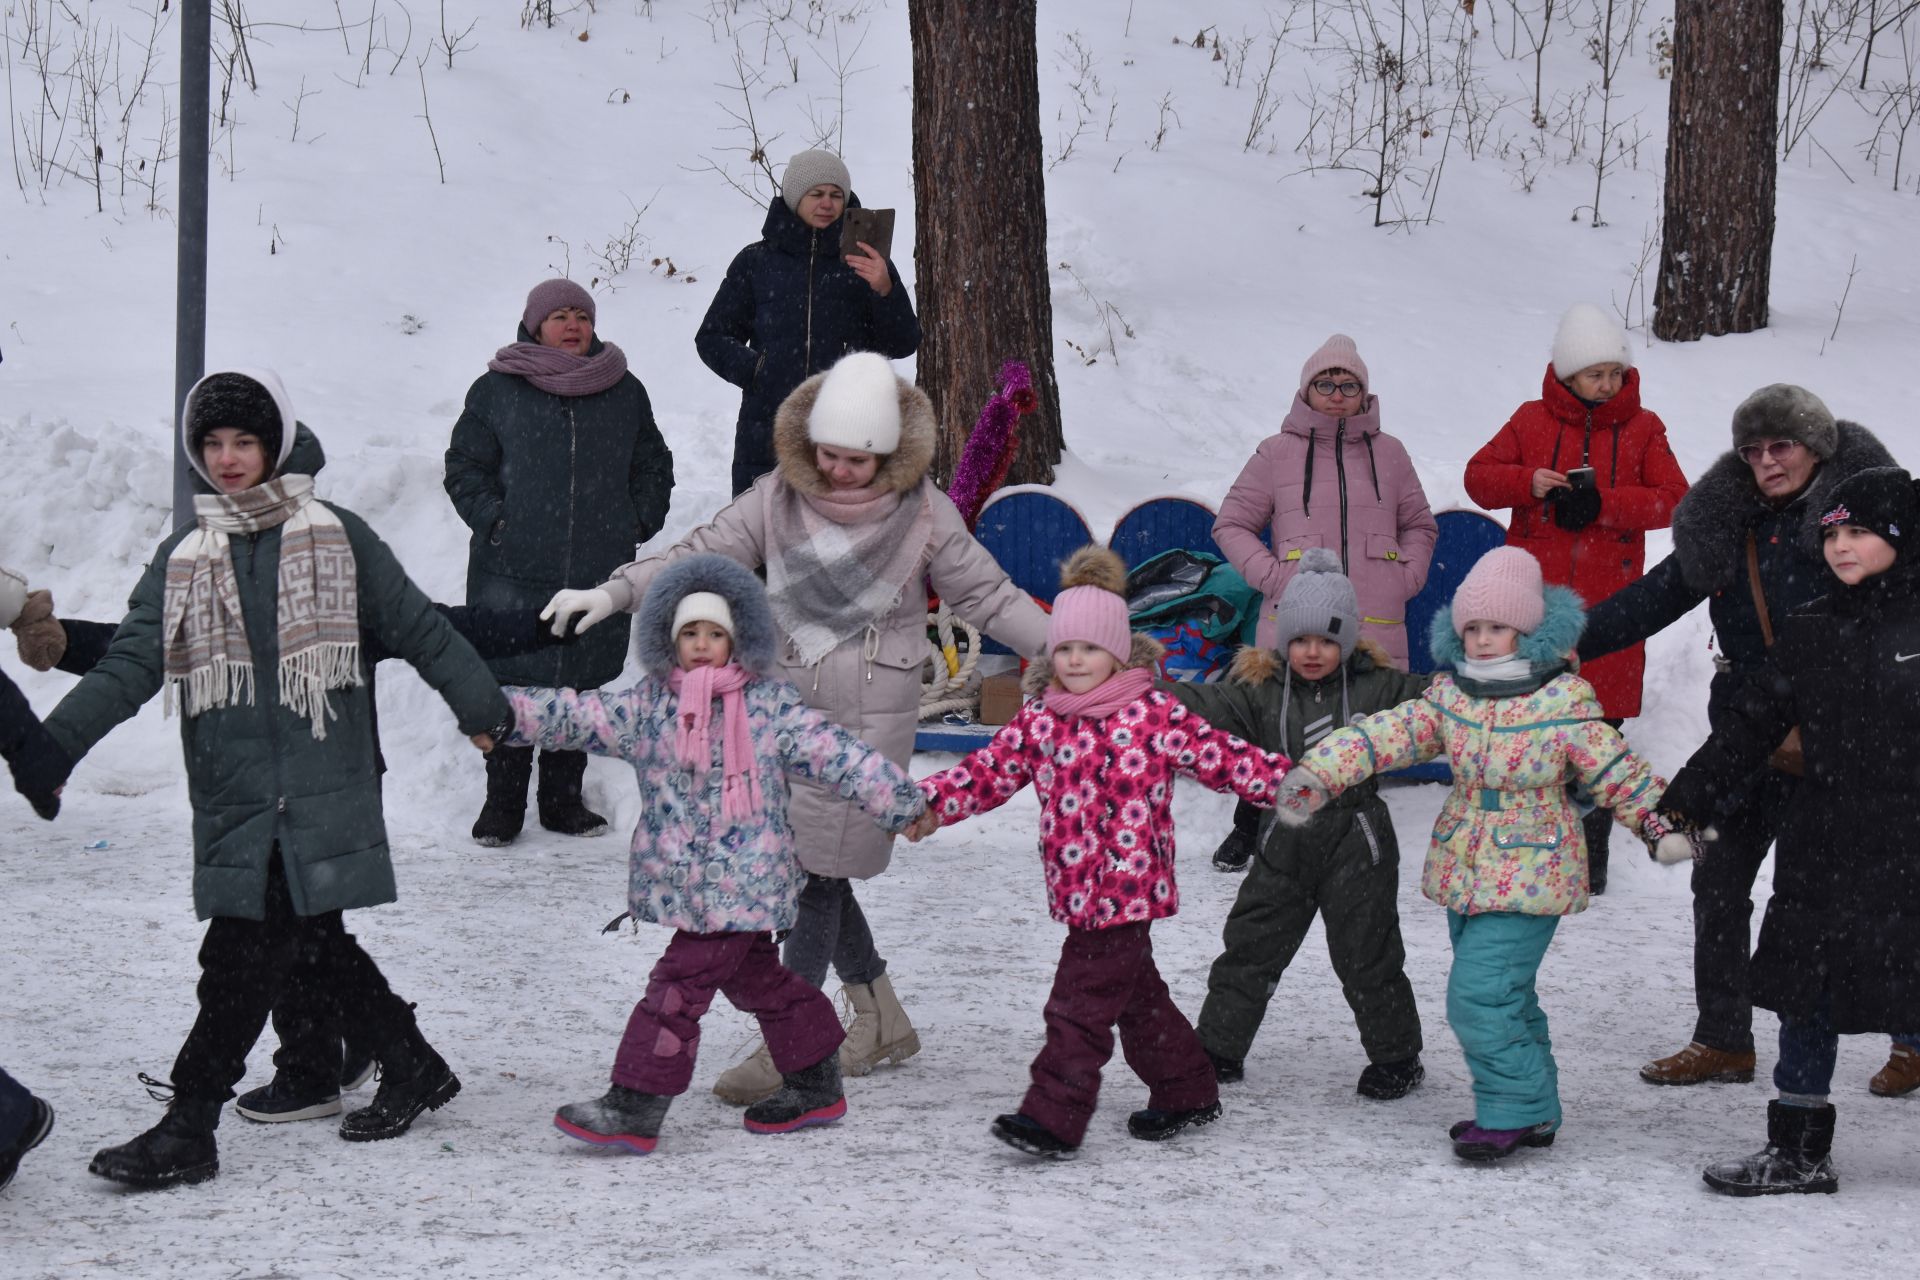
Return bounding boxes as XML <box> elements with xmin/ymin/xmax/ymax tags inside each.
<box><xmin>1162</xmin><ymin>547</ymin><xmax>1432</xmax><ymax>1100</ymax></box>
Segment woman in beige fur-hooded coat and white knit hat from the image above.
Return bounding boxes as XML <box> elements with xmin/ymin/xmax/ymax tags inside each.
<box><xmin>547</xmin><ymin>351</ymin><xmax>1046</xmax><ymax>1105</ymax></box>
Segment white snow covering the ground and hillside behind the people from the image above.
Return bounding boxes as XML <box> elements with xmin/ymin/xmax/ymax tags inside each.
<box><xmin>0</xmin><ymin>0</ymin><xmax>1920</xmax><ymax>1278</ymax></box>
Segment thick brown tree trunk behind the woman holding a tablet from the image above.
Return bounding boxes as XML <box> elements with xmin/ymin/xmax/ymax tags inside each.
<box><xmin>906</xmin><ymin>0</ymin><xmax>1062</xmax><ymax>484</ymax></box>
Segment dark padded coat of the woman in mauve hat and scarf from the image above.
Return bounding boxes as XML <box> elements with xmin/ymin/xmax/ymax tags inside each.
<box><xmin>445</xmin><ymin>324</ymin><xmax>674</xmax><ymax>689</ymax></box>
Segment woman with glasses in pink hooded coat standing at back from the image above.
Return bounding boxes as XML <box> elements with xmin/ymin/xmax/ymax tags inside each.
<box><xmin>1213</xmin><ymin>334</ymin><xmax>1440</xmax><ymax>871</ymax></box>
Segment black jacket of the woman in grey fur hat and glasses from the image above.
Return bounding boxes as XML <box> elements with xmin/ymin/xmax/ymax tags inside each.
<box><xmin>1580</xmin><ymin>422</ymin><xmax>1893</xmax><ymax>729</ymax></box>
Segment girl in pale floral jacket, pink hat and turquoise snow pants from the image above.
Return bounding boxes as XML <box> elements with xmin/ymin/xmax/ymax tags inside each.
<box><xmin>1275</xmin><ymin>547</ymin><xmax>1668</xmax><ymax>1161</ymax></box>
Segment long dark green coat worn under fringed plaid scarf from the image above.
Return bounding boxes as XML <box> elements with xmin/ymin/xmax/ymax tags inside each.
<box><xmin>46</xmin><ymin>503</ymin><xmax>513</xmax><ymax>919</ymax></box>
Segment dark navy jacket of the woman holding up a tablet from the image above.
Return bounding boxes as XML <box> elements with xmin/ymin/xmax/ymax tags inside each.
<box><xmin>693</xmin><ymin>194</ymin><xmax>920</xmax><ymax>483</ymax></box>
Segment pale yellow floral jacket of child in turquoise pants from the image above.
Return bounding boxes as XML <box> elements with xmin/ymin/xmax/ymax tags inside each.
<box><xmin>1300</xmin><ymin>675</ymin><xmax>1667</xmax><ymax>915</ymax></box>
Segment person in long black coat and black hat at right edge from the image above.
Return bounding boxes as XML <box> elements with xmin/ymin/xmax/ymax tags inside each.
<box><xmin>1657</xmin><ymin>466</ymin><xmax>1920</xmax><ymax>1196</ymax></box>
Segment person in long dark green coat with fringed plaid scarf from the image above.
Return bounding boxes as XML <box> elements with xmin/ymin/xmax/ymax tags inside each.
<box><xmin>46</xmin><ymin>370</ymin><xmax>513</xmax><ymax>1188</ymax></box>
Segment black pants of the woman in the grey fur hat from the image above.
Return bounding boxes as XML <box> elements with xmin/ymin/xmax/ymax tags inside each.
<box><xmin>1693</xmin><ymin>770</ymin><xmax>1799</xmax><ymax>1054</ymax></box>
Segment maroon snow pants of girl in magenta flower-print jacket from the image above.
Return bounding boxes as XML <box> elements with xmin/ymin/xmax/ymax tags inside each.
<box><xmin>1020</xmin><ymin>923</ymin><xmax>1219</xmax><ymax>1146</ymax></box>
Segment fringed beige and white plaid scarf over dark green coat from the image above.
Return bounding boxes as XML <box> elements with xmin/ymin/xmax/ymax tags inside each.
<box><xmin>161</xmin><ymin>476</ymin><xmax>361</xmax><ymax>739</ymax></box>
